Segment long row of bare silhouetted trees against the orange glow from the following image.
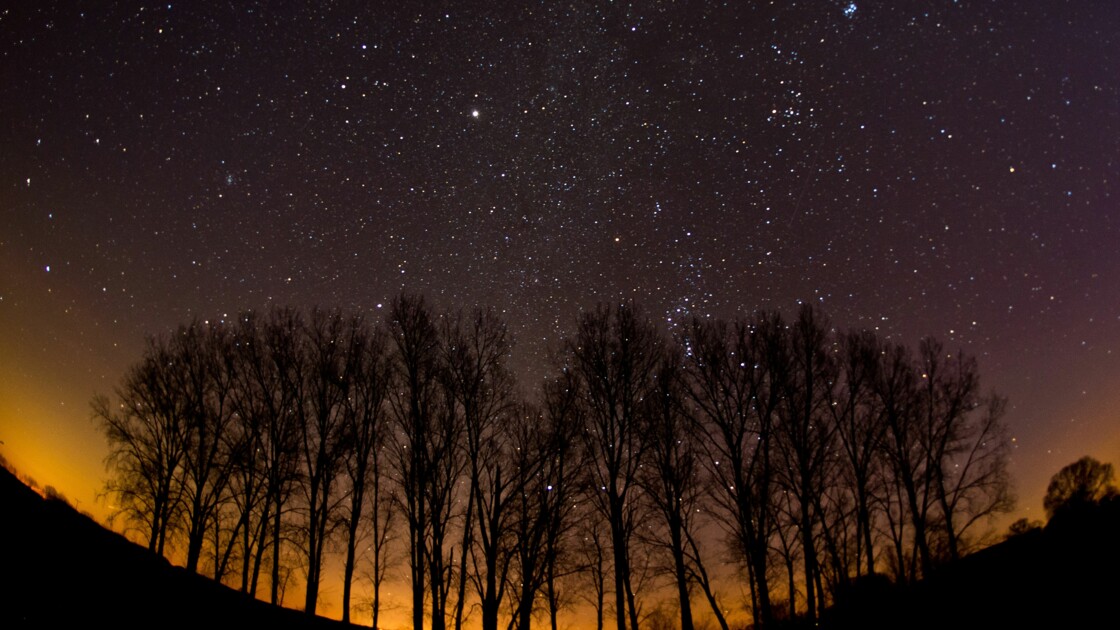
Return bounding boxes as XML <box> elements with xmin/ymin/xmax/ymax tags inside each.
<box><xmin>93</xmin><ymin>295</ymin><xmax>1012</xmax><ymax>630</ymax></box>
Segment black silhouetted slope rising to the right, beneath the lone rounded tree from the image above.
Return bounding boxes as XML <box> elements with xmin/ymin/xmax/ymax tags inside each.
<box><xmin>823</xmin><ymin>500</ymin><xmax>1120</xmax><ymax>630</ymax></box>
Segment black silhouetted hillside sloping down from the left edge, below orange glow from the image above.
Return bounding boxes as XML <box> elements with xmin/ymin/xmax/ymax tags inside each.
<box><xmin>0</xmin><ymin>467</ymin><xmax>349</xmax><ymax>630</ymax></box>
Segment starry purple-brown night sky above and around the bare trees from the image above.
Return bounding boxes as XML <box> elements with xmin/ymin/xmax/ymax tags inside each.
<box><xmin>0</xmin><ymin>0</ymin><xmax>1120</xmax><ymax>518</ymax></box>
